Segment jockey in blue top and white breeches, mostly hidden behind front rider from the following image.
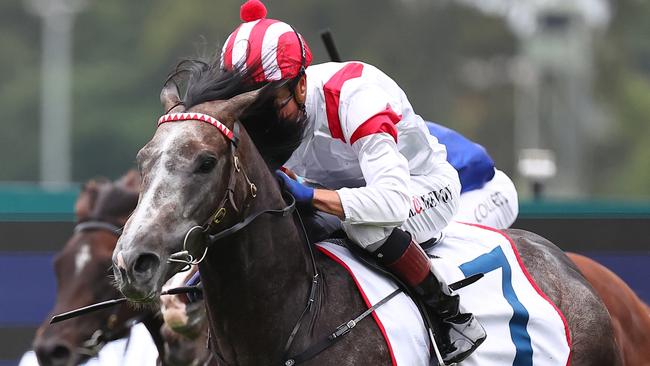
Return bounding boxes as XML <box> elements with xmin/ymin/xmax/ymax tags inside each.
<box><xmin>426</xmin><ymin>122</ymin><xmax>519</xmax><ymax>229</ymax></box>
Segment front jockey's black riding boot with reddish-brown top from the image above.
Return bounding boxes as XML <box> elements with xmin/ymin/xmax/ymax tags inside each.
<box><xmin>374</xmin><ymin>228</ymin><xmax>487</xmax><ymax>363</ymax></box>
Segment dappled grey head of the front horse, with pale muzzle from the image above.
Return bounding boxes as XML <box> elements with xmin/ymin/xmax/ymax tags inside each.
<box><xmin>113</xmin><ymin>75</ymin><xmax>266</xmax><ymax>302</ymax></box>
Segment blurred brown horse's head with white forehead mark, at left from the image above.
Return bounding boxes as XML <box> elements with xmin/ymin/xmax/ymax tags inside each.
<box><xmin>34</xmin><ymin>171</ymin><xmax>140</xmax><ymax>365</ymax></box>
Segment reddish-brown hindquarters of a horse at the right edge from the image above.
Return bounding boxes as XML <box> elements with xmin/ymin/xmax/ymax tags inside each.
<box><xmin>567</xmin><ymin>253</ymin><xmax>650</xmax><ymax>366</ymax></box>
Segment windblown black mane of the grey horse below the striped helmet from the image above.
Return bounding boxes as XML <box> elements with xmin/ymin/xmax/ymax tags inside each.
<box><xmin>168</xmin><ymin>57</ymin><xmax>305</xmax><ymax>169</ymax></box>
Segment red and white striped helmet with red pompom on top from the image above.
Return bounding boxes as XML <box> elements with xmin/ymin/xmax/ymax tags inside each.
<box><xmin>221</xmin><ymin>0</ymin><xmax>311</xmax><ymax>83</ymax></box>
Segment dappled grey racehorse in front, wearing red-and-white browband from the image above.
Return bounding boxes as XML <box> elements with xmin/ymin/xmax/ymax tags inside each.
<box><xmin>113</xmin><ymin>63</ymin><xmax>620</xmax><ymax>366</ymax></box>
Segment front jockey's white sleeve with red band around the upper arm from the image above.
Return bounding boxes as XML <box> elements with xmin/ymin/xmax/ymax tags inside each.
<box><xmin>336</xmin><ymin>84</ymin><xmax>411</xmax><ymax>228</ymax></box>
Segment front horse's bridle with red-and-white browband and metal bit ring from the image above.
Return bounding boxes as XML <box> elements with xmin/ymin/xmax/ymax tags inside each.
<box><xmin>158</xmin><ymin>113</ymin><xmax>295</xmax><ymax>272</ymax></box>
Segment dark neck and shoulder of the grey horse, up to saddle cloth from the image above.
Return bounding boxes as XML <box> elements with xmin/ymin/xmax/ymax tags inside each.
<box><xmin>199</xmin><ymin>142</ymin><xmax>390</xmax><ymax>365</ymax></box>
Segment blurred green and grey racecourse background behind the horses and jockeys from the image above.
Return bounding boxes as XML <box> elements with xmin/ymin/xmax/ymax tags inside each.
<box><xmin>0</xmin><ymin>0</ymin><xmax>650</xmax><ymax>365</ymax></box>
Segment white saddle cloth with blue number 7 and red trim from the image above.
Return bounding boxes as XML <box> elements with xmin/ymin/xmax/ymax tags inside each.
<box><xmin>317</xmin><ymin>222</ymin><xmax>571</xmax><ymax>366</ymax></box>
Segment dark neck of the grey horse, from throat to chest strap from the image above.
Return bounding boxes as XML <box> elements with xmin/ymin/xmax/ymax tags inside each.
<box><xmin>200</xmin><ymin>150</ymin><xmax>312</xmax><ymax>363</ymax></box>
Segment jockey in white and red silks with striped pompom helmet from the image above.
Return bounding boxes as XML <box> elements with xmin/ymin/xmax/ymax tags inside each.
<box><xmin>221</xmin><ymin>0</ymin><xmax>486</xmax><ymax>363</ymax></box>
